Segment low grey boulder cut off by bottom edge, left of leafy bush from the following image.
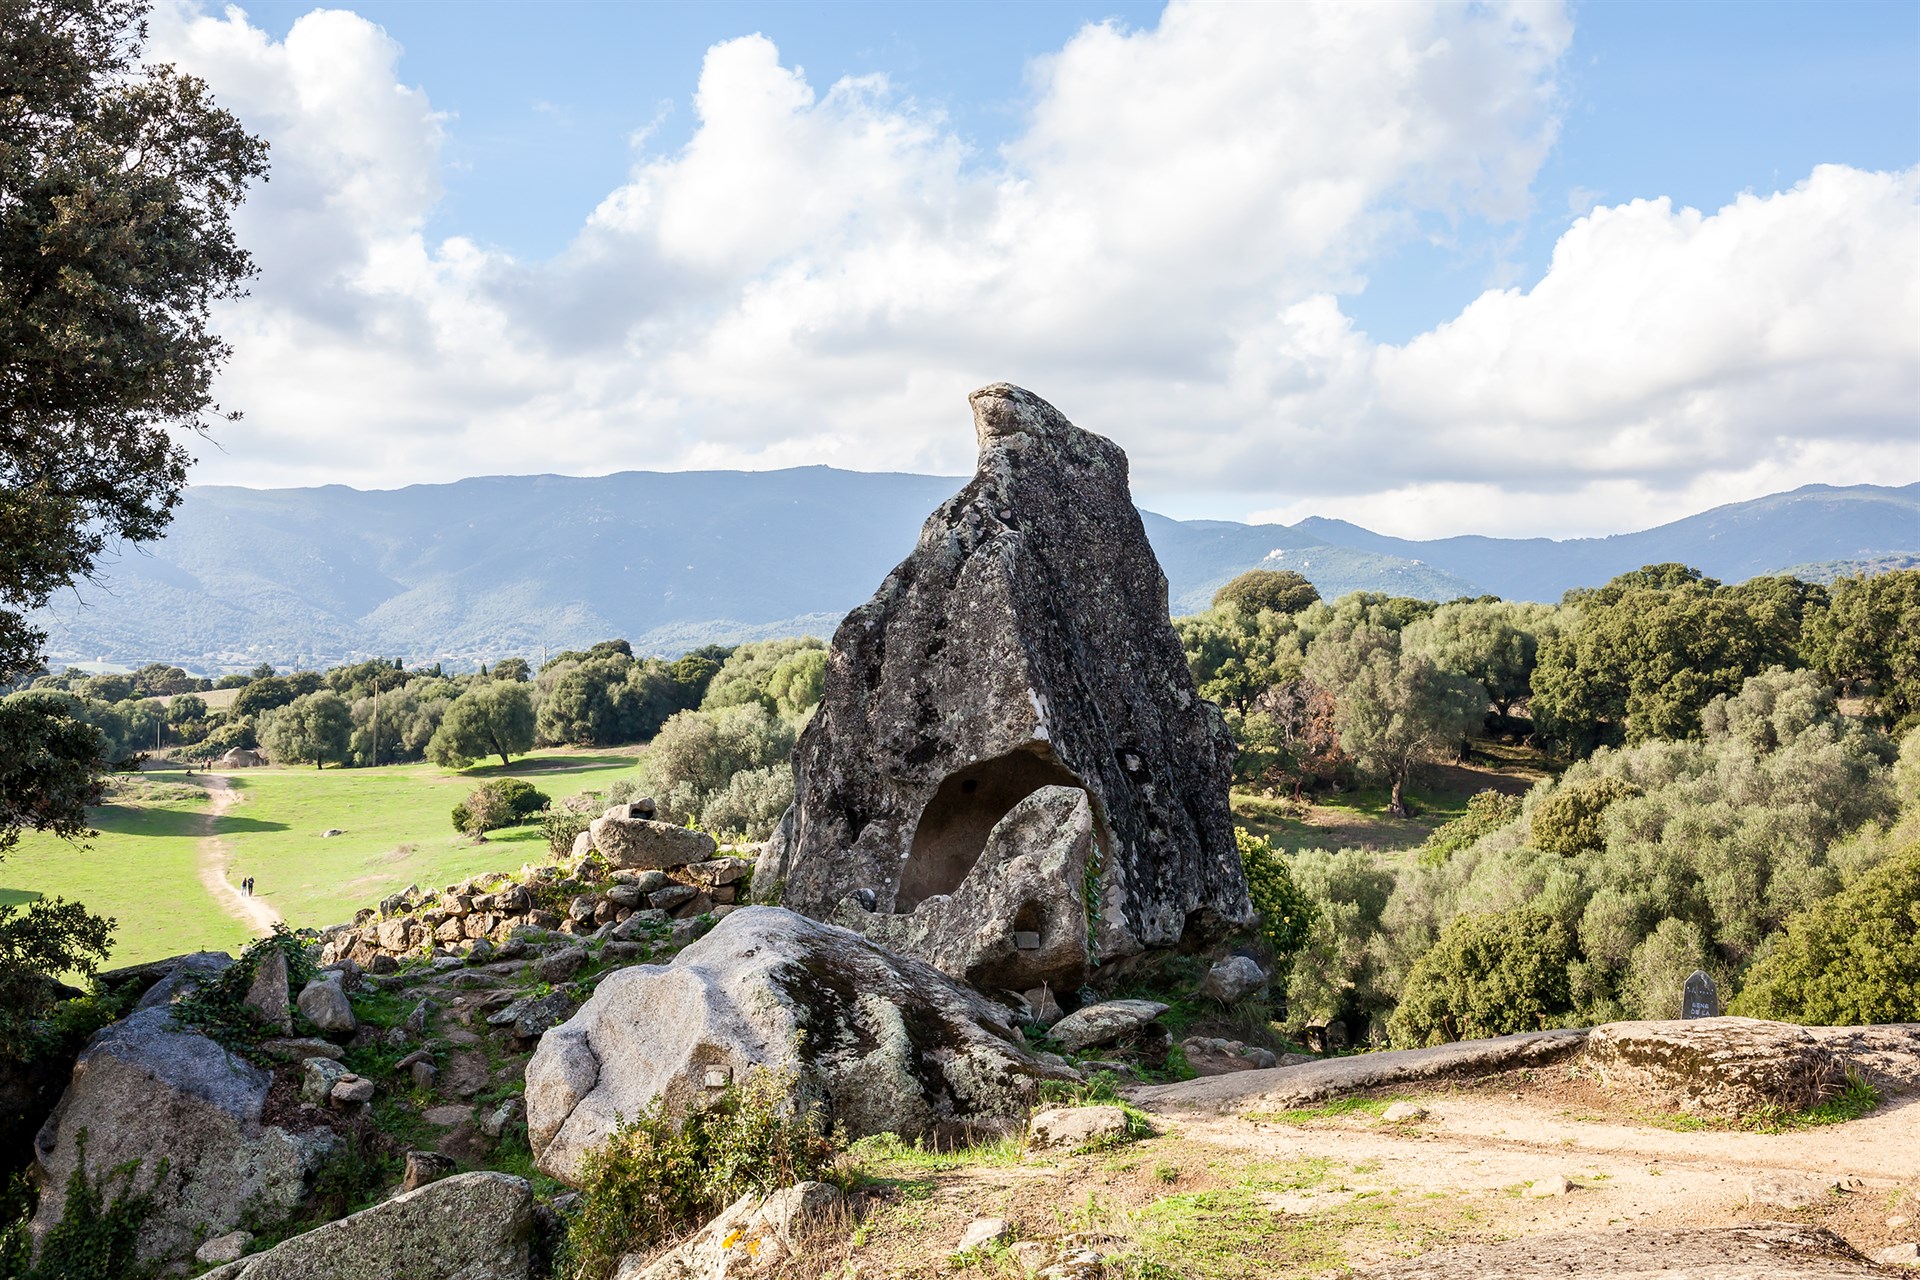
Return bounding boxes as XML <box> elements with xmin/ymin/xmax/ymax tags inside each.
<box><xmin>202</xmin><ymin>1173</ymin><xmax>534</xmax><ymax>1280</ymax></box>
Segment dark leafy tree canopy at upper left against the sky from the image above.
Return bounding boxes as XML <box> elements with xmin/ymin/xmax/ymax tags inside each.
<box><xmin>0</xmin><ymin>0</ymin><xmax>267</xmax><ymax>676</ymax></box>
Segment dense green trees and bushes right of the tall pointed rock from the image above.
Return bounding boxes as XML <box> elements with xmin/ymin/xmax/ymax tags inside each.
<box><xmin>1198</xmin><ymin>564</ymin><xmax>1920</xmax><ymax>1046</ymax></box>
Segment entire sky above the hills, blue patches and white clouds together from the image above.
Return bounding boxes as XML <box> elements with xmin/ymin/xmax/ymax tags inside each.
<box><xmin>156</xmin><ymin>0</ymin><xmax>1920</xmax><ymax>535</ymax></box>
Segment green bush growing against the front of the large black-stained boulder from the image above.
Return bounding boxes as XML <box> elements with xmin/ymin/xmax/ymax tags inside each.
<box><xmin>553</xmin><ymin>1071</ymin><xmax>837</xmax><ymax>1280</ymax></box>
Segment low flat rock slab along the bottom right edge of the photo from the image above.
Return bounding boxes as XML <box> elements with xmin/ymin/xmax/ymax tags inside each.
<box><xmin>1356</xmin><ymin>1222</ymin><xmax>1884</xmax><ymax>1280</ymax></box>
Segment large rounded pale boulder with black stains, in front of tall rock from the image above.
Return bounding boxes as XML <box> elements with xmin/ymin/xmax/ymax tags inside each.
<box><xmin>526</xmin><ymin>908</ymin><xmax>1069</xmax><ymax>1182</ymax></box>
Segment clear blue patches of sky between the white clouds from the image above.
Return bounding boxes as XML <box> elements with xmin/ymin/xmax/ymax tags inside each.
<box><xmin>242</xmin><ymin>0</ymin><xmax>1920</xmax><ymax>342</ymax></box>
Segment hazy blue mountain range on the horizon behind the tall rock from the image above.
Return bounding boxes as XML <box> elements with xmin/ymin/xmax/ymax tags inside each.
<box><xmin>38</xmin><ymin>466</ymin><xmax>1920</xmax><ymax>670</ymax></box>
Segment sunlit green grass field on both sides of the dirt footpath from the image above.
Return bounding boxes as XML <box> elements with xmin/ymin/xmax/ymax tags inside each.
<box><xmin>0</xmin><ymin>750</ymin><xmax>636</xmax><ymax>965</ymax></box>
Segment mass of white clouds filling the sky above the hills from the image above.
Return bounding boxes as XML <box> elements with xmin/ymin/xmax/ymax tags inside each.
<box><xmin>142</xmin><ymin>0</ymin><xmax>1920</xmax><ymax>533</ymax></box>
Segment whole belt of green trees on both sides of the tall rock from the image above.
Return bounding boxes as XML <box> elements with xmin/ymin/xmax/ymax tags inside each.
<box><xmin>10</xmin><ymin>564</ymin><xmax>1920</xmax><ymax>1044</ymax></box>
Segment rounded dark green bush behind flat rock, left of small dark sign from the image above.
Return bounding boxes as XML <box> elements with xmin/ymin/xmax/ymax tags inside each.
<box><xmin>1388</xmin><ymin>908</ymin><xmax>1572</xmax><ymax>1046</ymax></box>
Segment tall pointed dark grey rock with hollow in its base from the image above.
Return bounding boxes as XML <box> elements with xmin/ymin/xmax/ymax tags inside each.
<box><xmin>756</xmin><ymin>384</ymin><xmax>1252</xmax><ymax>961</ymax></box>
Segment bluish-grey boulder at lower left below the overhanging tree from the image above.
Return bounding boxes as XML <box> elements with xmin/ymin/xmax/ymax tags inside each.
<box><xmin>33</xmin><ymin>1007</ymin><xmax>334</xmax><ymax>1259</ymax></box>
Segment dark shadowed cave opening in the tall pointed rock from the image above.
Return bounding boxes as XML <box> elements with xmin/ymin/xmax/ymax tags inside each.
<box><xmin>893</xmin><ymin>745</ymin><xmax>1085</xmax><ymax>915</ymax></box>
